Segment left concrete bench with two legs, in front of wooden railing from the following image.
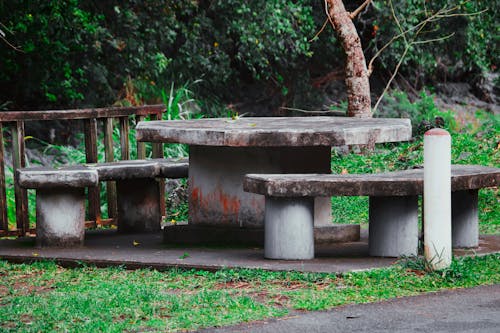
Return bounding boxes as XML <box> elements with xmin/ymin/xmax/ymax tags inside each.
<box><xmin>16</xmin><ymin>159</ymin><xmax>188</xmax><ymax>246</ymax></box>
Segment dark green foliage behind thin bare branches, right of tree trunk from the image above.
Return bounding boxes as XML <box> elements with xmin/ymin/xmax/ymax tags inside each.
<box><xmin>369</xmin><ymin>0</ymin><xmax>500</xmax><ymax>84</ymax></box>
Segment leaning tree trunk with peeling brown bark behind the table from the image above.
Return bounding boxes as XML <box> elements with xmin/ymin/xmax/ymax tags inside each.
<box><xmin>328</xmin><ymin>0</ymin><xmax>372</xmax><ymax>118</ymax></box>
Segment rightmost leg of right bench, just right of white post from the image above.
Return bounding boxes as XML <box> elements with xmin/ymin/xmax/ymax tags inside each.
<box><xmin>451</xmin><ymin>190</ymin><xmax>479</xmax><ymax>247</ymax></box>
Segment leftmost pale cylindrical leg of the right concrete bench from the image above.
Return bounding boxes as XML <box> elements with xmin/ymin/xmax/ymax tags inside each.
<box><xmin>264</xmin><ymin>197</ymin><xmax>314</xmax><ymax>260</ymax></box>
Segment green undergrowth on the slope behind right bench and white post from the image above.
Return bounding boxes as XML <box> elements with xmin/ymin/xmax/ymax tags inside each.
<box><xmin>332</xmin><ymin>92</ymin><xmax>500</xmax><ymax>233</ymax></box>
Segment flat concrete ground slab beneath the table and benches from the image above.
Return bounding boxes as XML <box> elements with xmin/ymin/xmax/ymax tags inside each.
<box><xmin>0</xmin><ymin>230</ymin><xmax>500</xmax><ymax>273</ymax></box>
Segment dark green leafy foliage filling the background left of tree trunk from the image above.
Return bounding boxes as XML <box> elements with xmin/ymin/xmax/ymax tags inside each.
<box><xmin>0</xmin><ymin>0</ymin><xmax>315</xmax><ymax>108</ymax></box>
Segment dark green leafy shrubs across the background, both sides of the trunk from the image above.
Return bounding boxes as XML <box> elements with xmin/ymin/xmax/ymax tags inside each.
<box><xmin>0</xmin><ymin>0</ymin><xmax>499</xmax><ymax>108</ymax></box>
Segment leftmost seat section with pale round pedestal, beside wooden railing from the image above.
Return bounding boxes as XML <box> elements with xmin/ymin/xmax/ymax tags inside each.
<box><xmin>16</xmin><ymin>166</ymin><xmax>99</xmax><ymax>247</ymax></box>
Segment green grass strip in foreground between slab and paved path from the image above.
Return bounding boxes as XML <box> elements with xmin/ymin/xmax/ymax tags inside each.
<box><xmin>0</xmin><ymin>254</ymin><xmax>500</xmax><ymax>332</ymax></box>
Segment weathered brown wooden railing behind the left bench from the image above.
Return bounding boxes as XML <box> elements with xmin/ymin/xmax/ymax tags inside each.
<box><xmin>0</xmin><ymin>105</ymin><xmax>165</xmax><ymax>236</ymax></box>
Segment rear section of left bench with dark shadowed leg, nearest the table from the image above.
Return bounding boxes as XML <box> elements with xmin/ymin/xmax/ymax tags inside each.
<box><xmin>92</xmin><ymin>159</ymin><xmax>188</xmax><ymax>232</ymax></box>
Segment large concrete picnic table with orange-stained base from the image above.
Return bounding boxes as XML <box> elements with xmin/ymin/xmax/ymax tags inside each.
<box><xmin>137</xmin><ymin>116</ymin><xmax>411</xmax><ymax>233</ymax></box>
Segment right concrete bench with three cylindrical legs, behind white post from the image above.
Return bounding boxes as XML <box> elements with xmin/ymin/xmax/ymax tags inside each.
<box><xmin>243</xmin><ymin>165</ymin><xmax>500</xmax><ymax>259</ymax></box>
